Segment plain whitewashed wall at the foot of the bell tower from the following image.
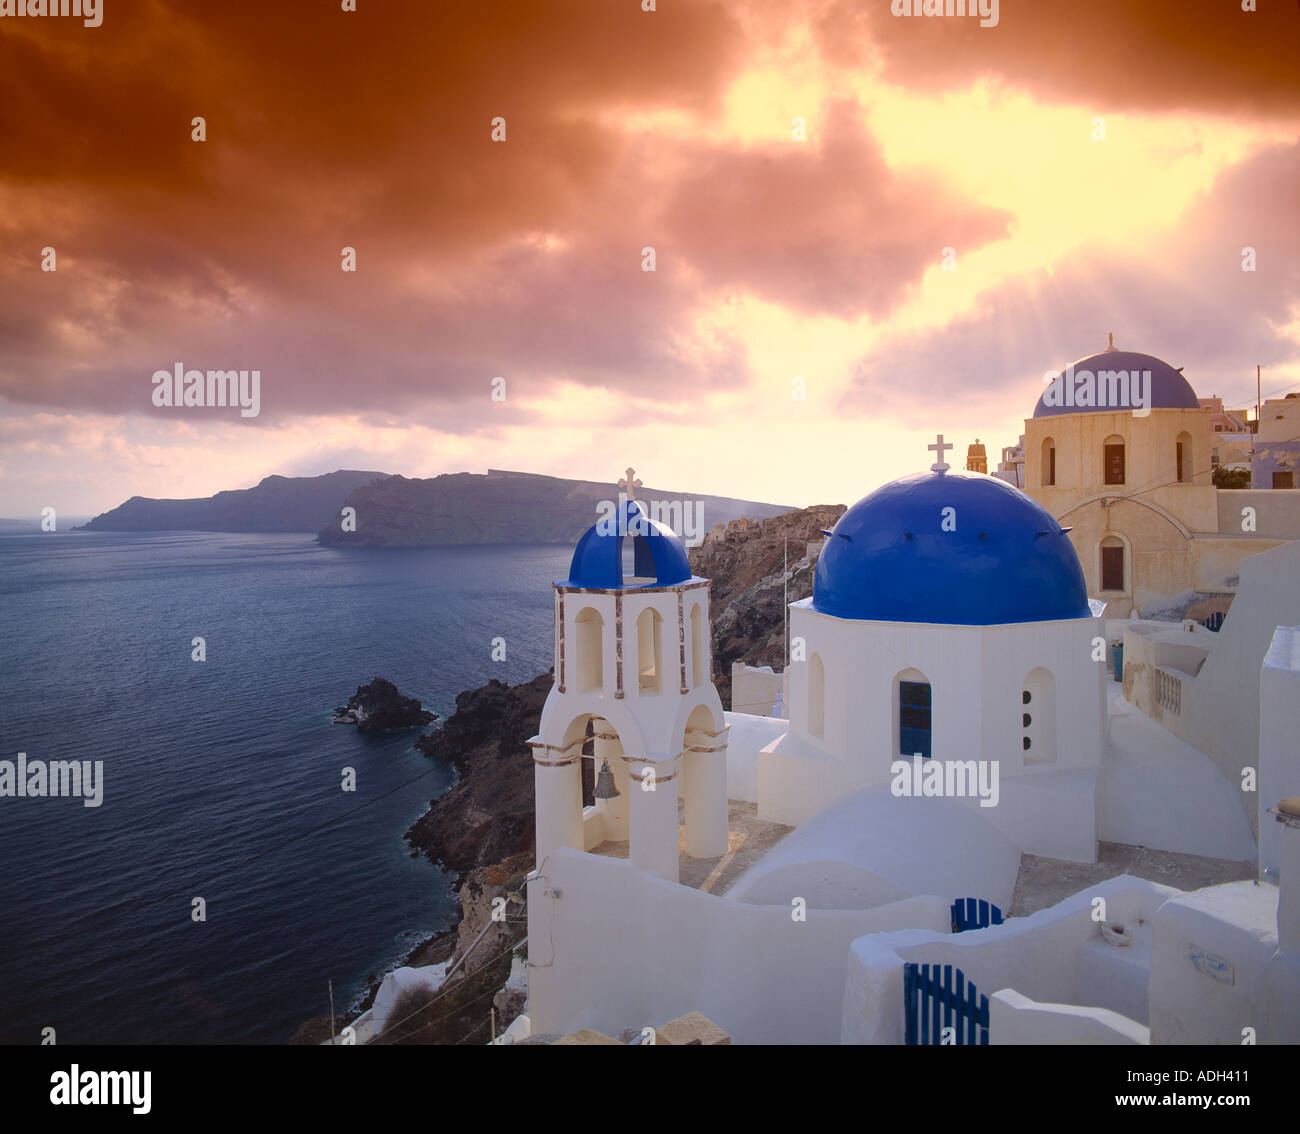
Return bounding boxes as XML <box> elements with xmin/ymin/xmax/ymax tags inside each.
<box><xmin>528</xmin><ymin>848</ymin><xmax>949</xmax><ymax>1043</ymax></box>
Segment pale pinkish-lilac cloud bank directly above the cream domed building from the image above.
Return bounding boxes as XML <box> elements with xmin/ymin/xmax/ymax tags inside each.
<box><xmin>840</xmin><ymin>144</ymin><xmax>1300</xmax><ymax>425</ymax></box>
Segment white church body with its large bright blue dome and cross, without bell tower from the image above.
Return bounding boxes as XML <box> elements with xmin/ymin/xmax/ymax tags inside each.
<box><xmin>757</xmin><ymin>438</ymin><xmax>1105</xmax><ymax>862</ymax></box>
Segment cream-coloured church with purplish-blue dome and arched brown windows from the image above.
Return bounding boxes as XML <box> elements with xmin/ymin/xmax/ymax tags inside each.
<box><xmin>1024</xmin><ymin>341</ymin><xmax>1300</xmax><ymax>618</ymax></box>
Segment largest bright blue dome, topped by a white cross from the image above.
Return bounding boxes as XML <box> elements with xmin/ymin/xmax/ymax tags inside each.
<box><xmin>813</xmin><ymin>472</ymin><xmax>1091</xmax><ymax>626</ymax></box>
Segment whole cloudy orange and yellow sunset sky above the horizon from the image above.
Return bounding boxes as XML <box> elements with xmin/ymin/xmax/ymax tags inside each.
<box><xmin>0</xmin><ymin>0</ymin><xmax>1300</xmax><ymax>516</ymax></box>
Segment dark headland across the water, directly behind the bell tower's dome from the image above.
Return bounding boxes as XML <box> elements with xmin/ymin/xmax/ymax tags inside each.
<box><xmin>317</xmin><ymin>469</ymin><xmax>785</xmax><ymax>547</ymax></box>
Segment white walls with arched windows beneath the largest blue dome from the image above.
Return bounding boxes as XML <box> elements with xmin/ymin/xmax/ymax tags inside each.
<box><xmin>758</xmin><ymin>600</ymin><xmax>1106</xmax><ymax>862</ymax></box>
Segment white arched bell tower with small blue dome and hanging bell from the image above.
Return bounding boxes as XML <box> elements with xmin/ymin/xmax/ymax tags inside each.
<box><xmin>529</xmin><ymin>468</ymin><xmax>727</xmax><ymax>882</ymax></box>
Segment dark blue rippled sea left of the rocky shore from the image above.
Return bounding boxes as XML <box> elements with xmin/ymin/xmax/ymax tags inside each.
<box><xmin>0</xmin><ymin>532</ymin><xmax>571</xmax><ymax>1044</ymax></box>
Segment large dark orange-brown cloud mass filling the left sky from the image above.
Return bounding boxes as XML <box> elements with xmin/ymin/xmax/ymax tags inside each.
<box><xmin>0</xmin><ymin>0</ymin><xmax>1005</xmax><ymax>421</ymax></box>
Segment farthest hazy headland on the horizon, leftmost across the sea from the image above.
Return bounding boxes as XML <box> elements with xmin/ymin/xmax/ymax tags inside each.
<box><xmin>75</xmin><ymin>469</ymin><xmax>387</xmax><ymax>532</ymax></box>
